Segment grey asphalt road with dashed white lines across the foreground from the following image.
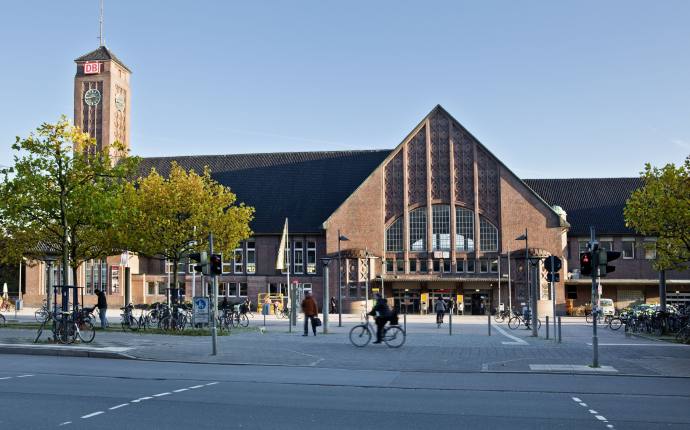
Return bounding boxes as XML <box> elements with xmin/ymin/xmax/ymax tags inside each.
<box><xmin>0</xmin><ymin>355</ymin><xmax>690</xmax><ymax>430</ymax></box>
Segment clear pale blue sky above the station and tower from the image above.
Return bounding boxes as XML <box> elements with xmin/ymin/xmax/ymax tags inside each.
<box><xmin>0</xmin><ymin>0</ymin><xmax>690</xmax><ymax>178</ymax></box>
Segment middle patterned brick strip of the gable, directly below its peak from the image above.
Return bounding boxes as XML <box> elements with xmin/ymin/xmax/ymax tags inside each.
<box><xmin>430</xmin><ymin>112</ymin><xmax>450</xmax><ymax>201</ymax></box>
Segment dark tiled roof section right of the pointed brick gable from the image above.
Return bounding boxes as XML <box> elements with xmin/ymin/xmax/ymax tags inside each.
<box><xmin>524</xmin><ymin>178</ymin><xmax>644</xmax><ymax>236</ymax></box>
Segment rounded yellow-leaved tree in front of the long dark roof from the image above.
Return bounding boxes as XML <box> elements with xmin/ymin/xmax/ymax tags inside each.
<box><xmin>119</xmin><ymin>162</ymin><xmax>254</xmax><ymax>298</ymax></box>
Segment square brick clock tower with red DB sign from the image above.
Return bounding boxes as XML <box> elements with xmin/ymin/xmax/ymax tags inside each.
<box><xmin>74</xmin><ymin>45</ymin><xmax>132</xmax><ymax>160</ymax></box>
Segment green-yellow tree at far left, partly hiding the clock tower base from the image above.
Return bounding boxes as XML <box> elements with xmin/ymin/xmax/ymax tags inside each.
<box><xmin>0</xmin><ymin>116</ymin><xmax>139</xmax><ymax>285</ymax></box>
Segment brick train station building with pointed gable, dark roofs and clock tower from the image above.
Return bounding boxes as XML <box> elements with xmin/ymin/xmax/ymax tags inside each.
<box><xmin>13</xmin><ymin>46</ymin><xmax>690</xmax><ymax>315</ymax></box>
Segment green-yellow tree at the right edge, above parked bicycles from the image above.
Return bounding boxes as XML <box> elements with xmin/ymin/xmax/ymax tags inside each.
<box><xmin>624</xmin><ymin>156</ymin><xmax>690</xmax><ymax>270</ymax></box>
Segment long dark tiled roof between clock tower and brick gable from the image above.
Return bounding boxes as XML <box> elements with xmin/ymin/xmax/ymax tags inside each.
<box><xmin>140</xmin><ymin>150</ymin><xmax>390</xmax><ymax>233</ymax></box>
